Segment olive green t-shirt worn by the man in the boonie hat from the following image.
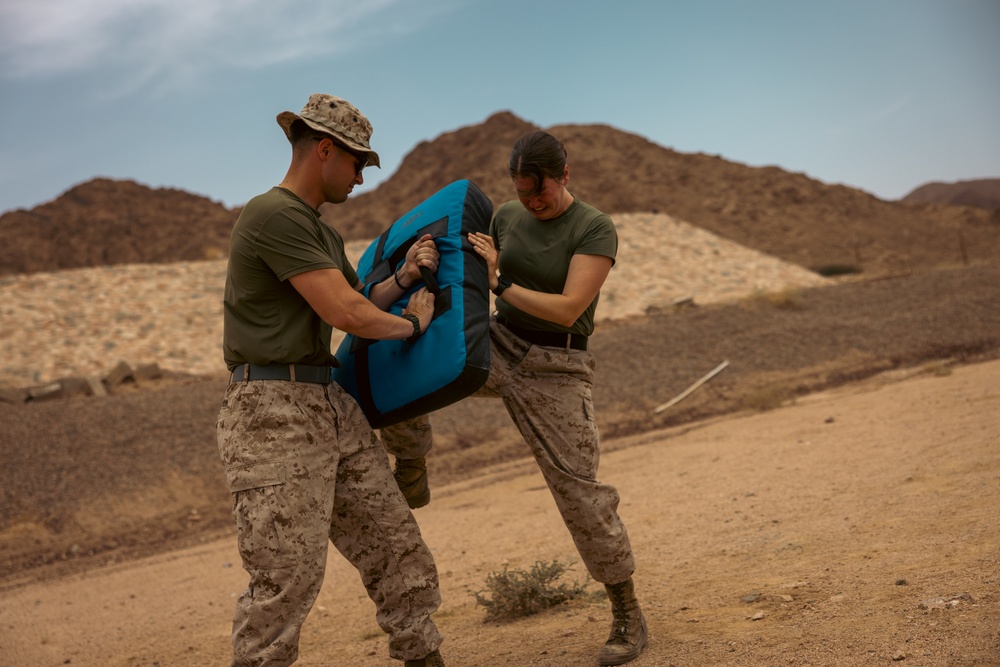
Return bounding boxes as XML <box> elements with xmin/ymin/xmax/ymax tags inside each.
<box><xmin>222</xmin><ymin>187</ymin><xmax>359</xmax><ymax>369</ymax></box>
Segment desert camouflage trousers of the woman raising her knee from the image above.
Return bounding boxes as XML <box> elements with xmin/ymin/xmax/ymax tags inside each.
<box><xmin>381</xmin><ymin>320</ymin><xmax>635</xmax><ymax>584</ymax></box>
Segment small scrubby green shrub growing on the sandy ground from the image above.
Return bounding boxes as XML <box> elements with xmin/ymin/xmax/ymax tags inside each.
<box><xmin>475</xmin><ymin>560</ymin><xmax>586</xmax><ymax>622</ymax></box>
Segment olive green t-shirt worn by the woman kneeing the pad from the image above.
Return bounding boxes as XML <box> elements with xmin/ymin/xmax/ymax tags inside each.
<box><xmin>490</xmin><ymin>199</ymin><xmax>618</xmax><ymax>336</ymax></box>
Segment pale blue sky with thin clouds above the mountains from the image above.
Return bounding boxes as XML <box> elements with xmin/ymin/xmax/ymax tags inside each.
<box><xmin>0</xmin><ymin>0</ymin><xmax>1000</xmax><ymax>213</ymax></box>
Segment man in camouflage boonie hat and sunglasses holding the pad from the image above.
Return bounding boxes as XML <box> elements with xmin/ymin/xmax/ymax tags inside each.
<box><xmin>218</xmin><ymin>94</ymin><xmax>444</xmax><ymax>667</ymax></box>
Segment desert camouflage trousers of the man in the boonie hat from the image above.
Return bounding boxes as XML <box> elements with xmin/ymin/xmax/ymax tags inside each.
<box><xmin>217</xmin><ymin>381</ymin><xmax>441</xmax><ymax>667</ymax></box>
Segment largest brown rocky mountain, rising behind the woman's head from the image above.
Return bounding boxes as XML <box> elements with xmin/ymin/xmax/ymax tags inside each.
<box><xmin>334</xmin><ymin>112</ymin><xmax>1000</xmax><ymax>275</ymax></box>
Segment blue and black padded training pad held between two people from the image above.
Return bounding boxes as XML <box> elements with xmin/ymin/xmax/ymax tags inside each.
<box><xmin>333</xmin><ymin>180</ymin><xmax>493</xmax><ymax>428</ymax></box>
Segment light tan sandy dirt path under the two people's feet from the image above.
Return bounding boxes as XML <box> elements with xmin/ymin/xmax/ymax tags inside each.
<box><xmin>0</xmin><ymin>361</ymin><xmax>1000</xmax><ymax>667</ymax></box>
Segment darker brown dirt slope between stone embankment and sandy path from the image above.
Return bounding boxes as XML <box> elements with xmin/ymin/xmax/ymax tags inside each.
<box><xmin>0</xmin><ymin>264</ymin><xmax>1000</xmax><ymax>585</ymax></box>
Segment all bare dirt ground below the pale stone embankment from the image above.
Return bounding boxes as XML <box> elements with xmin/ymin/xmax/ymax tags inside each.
<box><xmin>0</xmin><ymin>252</ymin><xmax>1000</xmax><ymax>667</ymax></box>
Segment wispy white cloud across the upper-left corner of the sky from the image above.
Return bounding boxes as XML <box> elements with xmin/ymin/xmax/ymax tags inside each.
<box><xmin>0</xmin><ymin>0</ymin><xmax>420</xmax><ymax>82</ymax></box>
